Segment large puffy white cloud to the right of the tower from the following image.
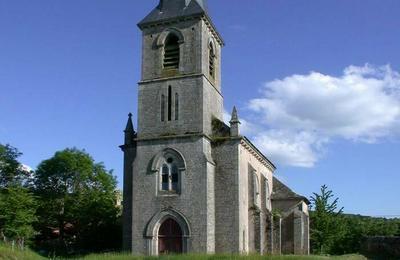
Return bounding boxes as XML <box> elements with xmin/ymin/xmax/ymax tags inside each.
<box><xmin>242</xmin><ymin>64</ymin><xmax>400</xmax><ymax>167</ymax></box>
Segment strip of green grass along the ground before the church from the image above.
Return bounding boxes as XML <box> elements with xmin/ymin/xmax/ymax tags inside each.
<box><xmin>0</xmin><ymin>245</ymin><xmax>366</xmax><ymax>260</ymax></box>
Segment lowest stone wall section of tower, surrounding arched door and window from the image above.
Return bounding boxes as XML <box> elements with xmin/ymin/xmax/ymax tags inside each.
<box><xmin>132</xmin><ymin>137</ymin><xmax>215</xmax><ymax>254</ymax></box>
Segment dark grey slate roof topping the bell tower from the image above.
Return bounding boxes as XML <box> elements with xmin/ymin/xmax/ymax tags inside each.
<box><xmin>138</xmin><ymin>0</ymin><xmax>207</xmax><ymax>28</ymax></box>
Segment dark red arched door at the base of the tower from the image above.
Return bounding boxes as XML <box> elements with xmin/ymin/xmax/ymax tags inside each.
<box><xmin>158</xmin><ymin>218</ymin><xmax>183</xmax><ymax>254</ymax></box>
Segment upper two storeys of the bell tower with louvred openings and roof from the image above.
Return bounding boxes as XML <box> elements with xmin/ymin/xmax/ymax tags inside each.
<box><xmin>138</xmin><ymin>0</ymin><xmax>223</xmax><ymax>138</ymax></box>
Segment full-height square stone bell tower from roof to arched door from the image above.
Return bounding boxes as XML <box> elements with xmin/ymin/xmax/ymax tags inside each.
<box><xmin>121</xmin><ymin>0</ymin><xmax>223</xmax><ymax>255</ymax></box>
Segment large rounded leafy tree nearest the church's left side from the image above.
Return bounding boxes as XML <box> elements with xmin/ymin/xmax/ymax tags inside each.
<box><xmin>34</xmin><ymin>148</ymin><xmax>120</xmax><ymax>254</ymax></box>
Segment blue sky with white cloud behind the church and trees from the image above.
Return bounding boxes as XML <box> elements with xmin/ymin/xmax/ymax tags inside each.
<box><xmin>0</xmin><ymin>0</ymin><xmax>400</xmax><ymax>216</ymax></box>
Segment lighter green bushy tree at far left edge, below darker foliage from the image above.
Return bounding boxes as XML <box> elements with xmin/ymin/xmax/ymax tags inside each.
<box><xmin>0</xmin><ymin>186</ymin><xmax>37</xmax><ymax>249</ymax></box>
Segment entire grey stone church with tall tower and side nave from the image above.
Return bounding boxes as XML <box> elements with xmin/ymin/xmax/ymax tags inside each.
<box><xmin>121</xmin><ymin>0</ymin><xmax>309</xmax><ymax>255</ymax></box>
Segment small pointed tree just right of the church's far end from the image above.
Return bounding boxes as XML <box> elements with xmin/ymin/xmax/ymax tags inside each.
<box><xmin>310</xmin><ymin>185</ymin><xmax>343</xmax><ymax>254</ymax></box>
